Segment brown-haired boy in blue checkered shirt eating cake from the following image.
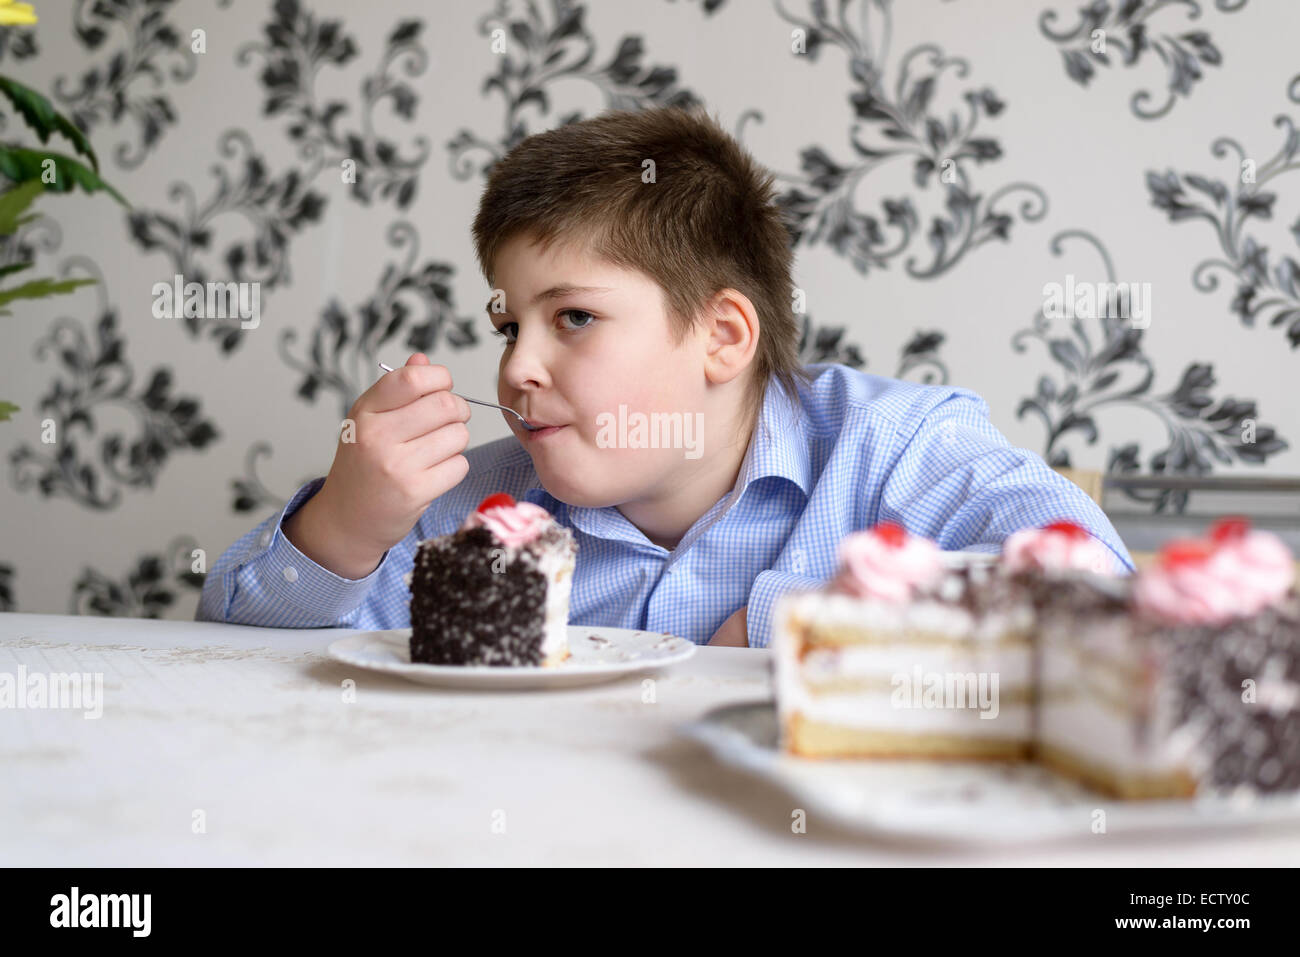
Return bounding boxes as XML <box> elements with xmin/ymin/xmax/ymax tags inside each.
<box><xmin>199</xmin><ymin>108</ymin><xmax>1132</xmax><ymax>648</ymax></box>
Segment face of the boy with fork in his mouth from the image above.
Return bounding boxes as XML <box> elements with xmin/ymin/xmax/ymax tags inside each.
<box><xmin>488</xmin><ymin>237</ymin><xmax>711</xmax><ymax>508</ymax></box>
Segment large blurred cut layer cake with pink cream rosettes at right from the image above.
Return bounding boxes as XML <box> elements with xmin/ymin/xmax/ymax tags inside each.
<box><xmin>772</xmin><ymin>519</ymin><xmax>1300</xmax><ymax>798</ymax></box>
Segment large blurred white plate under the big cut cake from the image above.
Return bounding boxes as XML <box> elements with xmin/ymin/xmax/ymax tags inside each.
<box><xmin>680</xmin><ymin>701</ymin><xmax>1300</xmax><ymax>845</ymax></box>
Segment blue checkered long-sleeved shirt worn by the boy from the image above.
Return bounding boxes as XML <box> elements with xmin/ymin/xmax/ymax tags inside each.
<box><xmin>198</xmin><ymin>363</ymin><xmax>1134</xmax><ymax>648</ymax></box>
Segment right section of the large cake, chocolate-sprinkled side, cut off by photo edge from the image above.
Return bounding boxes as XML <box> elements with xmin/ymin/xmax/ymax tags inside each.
<box><xmin>1035</xmin><ymin>520</ymin><xmax>1300</xmax><ymax>798</ymax></box>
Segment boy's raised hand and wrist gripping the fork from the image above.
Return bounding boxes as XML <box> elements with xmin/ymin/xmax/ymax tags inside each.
<box><xmin>283</xmin><ymin>352</ymin><xmax>471</xmax><ymax>579</ymax></box>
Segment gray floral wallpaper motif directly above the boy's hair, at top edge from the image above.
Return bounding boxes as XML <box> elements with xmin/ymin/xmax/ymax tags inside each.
<box><xmin>447</xmin><ymin>0</ymin><xmax>699</xmax><ymax>179</ymax></box>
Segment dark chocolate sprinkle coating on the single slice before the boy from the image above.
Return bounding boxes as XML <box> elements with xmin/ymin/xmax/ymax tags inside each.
<box><xmin>411</xmin><ymin>525</ymin><xmax>577</xmax><ymax>667</ymax></box>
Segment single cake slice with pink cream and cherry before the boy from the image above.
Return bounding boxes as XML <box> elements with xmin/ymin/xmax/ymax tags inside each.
<box><xmin>408</xmin><ymin>493</ymin><xmax>577</xmax><ymax>666</ymax></box>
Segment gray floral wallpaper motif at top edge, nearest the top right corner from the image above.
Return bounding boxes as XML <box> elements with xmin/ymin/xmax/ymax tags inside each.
<box><xmin>1039</xmin><ymin>0</ymin><xmax>1247</xmax><ymax>120</ymax></box>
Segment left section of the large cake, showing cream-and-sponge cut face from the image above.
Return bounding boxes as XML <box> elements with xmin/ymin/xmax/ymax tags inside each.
<box><xmin>772</xmin><ymin>523</ymin><xmax>1034</xmax><ymax>759</ymax></box>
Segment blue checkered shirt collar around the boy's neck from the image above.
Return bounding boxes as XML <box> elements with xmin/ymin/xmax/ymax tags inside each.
<box><xmin>523</xmin><ymin>376</ymin><xmax>813</xmax><ymax>538</ymax></box>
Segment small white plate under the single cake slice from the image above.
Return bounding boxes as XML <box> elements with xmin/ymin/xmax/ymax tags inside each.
<box><xmin>329</xmin><ymin>625</ymin><xmax>696</xmax><ymax>690</ymax></box>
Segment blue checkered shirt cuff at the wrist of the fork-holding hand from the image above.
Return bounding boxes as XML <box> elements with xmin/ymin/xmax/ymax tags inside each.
<box><xmin>244</xmin><ymin>479</ymin><xmax>391</xmax><ymax>622</ymax></box>
